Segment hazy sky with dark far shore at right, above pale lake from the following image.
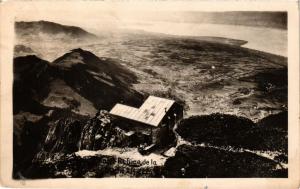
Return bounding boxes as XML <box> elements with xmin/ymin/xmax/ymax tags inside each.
<box><xmin>16</xmin><ymin>10</ymin><xmax>287</xmax><ymax>29</ymax></box>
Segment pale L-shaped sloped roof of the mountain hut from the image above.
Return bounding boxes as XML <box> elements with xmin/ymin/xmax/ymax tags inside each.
<box><xmin>110</xmin><ymin>96</ymin><xmax>175</xmax><ymax>126</ymax></box>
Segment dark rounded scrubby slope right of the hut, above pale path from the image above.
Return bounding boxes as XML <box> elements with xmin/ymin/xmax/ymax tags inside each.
<box><xmin>177</xmin><ymin>112</ymin><xmax>288</xmax><ymax>155</ymax></box>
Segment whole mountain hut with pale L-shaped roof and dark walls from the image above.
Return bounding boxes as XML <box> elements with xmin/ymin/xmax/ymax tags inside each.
<box><xmin>110</xmin><ymin>96</ymin><xmax>183</xmax><ymax>144</ymax></box>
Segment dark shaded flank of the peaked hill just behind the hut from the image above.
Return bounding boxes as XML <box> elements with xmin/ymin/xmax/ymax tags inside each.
<box><xmin>53</xmin><ymin>49</ymin><xmax>142</xmax><ymax>110</ymax></box>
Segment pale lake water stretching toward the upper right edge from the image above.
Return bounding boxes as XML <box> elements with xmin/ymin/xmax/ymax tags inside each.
<box><xmin>126</xmin><ymin>22</ymin><xmax>287</xmax><ymax>57</ymax></box>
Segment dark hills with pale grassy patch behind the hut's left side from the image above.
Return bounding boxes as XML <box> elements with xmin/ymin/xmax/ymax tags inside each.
<box><xmin>14</xmin><ymin>49</ymin><xmax>142</xmax><ymax>115</ymax></box>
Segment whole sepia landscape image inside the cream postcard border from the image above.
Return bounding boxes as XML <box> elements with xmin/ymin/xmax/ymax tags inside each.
<box><xmin>12</xmin><ymin>11</ymin><xmax>288</xmax><ymax>179</ymax></box>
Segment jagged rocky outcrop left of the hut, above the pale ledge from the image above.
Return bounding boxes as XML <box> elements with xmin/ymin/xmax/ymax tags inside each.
<box><xmin>32</xmin><ymin>110</ymin><xmax>150</xmax><ymax>159</ymax></box>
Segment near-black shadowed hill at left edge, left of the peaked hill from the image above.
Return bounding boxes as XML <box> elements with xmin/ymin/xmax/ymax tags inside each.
<box><xmin>13</xmin><ymin>55</ymin><xmax>51</xmax><ymax>114</ymax></box>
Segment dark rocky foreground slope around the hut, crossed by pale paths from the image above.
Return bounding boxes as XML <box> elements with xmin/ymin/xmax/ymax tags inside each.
<box><xmin>15</xmin><ymin>111</ymin><xmax>287</xmax><ymax>178</ymax></box>
